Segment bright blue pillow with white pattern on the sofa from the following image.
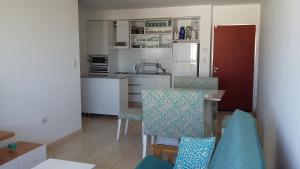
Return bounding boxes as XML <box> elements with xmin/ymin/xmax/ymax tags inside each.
<box><xmin>174</xmin><ymin>137</ymin><xmax>216</xmax><ymax>169</ymax></box>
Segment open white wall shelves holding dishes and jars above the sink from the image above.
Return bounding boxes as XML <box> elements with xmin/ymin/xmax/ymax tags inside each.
<box><xmin>110</xmin><ymin>16</ymin><xmax>200</xmax><ymax>49</ymax></box>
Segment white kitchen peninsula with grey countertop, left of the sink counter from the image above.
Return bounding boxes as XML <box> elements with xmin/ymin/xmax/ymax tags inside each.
<box><xmin>81</xmin><ymin>74</ymin><xmax>128</xmax><ymax>115</ymax></box>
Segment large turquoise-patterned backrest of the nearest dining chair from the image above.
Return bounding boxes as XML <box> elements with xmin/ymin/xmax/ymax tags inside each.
<box><xmin>142</xmin><ymin>89</ymin><xmax>205</xmax><ymax>138</ymax></box>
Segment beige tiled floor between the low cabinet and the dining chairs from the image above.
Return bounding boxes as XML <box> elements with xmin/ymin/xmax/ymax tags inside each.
<box><xmin>48</xmin><ymin>116</ymin><xmax>142</xmax><ymax>169</ymax></box>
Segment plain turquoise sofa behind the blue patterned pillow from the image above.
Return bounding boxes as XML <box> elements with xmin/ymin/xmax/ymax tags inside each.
<box><xmin>136</xmin><ymin>110</ymin><xmax>265</xmax><ymax>169</ymax></box>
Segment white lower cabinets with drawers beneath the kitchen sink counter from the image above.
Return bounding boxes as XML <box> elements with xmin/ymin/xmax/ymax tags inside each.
<box><xmin>128</xmin><ymin>75</ymin><xmax>171</xmax><ymax>102</ymax></box>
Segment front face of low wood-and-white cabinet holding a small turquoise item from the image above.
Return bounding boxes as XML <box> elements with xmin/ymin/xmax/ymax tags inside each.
<box><xmin>0</xmin><ymin>145</ymin><xmax>47</xmax><ymax>169</ymax></box>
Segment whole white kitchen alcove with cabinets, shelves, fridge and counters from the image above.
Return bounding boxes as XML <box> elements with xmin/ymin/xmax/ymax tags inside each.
<box><xmin>81</xmin><ymin>16</ymin><xmax>201</xmax><ymax>115</ymax></box>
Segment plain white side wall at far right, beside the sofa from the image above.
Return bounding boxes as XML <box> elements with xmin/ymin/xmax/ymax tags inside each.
<box><xmin>257</xmin><ymin>0</ymin><xmax>300</xmax><ymax>169</ymax></box>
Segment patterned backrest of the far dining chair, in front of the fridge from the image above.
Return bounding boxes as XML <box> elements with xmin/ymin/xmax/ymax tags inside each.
<box><xmin>174</xmin><ymin>76</ymin><xmax>219</xmax><ymax>90</ymax></box>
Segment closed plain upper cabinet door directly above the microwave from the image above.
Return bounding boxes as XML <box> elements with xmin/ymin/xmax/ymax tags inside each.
<box><xmin>86</xmin><ymin>21</ymin><xmax>110</xmax><ymax>55</ymax></box>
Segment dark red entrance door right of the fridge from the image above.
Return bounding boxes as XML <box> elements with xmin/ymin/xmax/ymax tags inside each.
<box><xmin>213</xmin><ymin>25</ymin><xmax>256</xmax><ymax>112</ymax></box>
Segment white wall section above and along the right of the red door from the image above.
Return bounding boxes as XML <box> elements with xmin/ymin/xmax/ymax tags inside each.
<box><xmin>212</xmin><ymin>4</ymin><xmax>261</xmax><ymax>111</ymax></box>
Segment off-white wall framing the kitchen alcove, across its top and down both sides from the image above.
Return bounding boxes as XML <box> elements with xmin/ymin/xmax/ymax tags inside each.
<box><xmin>80</xmin><ymin>5</ymin><xmax>211</xmax><ymax>76</ymax></box>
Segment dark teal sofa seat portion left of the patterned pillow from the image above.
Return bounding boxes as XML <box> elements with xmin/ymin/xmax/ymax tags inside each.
<box><xmin>136</xmin><ymin>155</ymin><xmax>174</xmax><ymax>169</ymax></box>
